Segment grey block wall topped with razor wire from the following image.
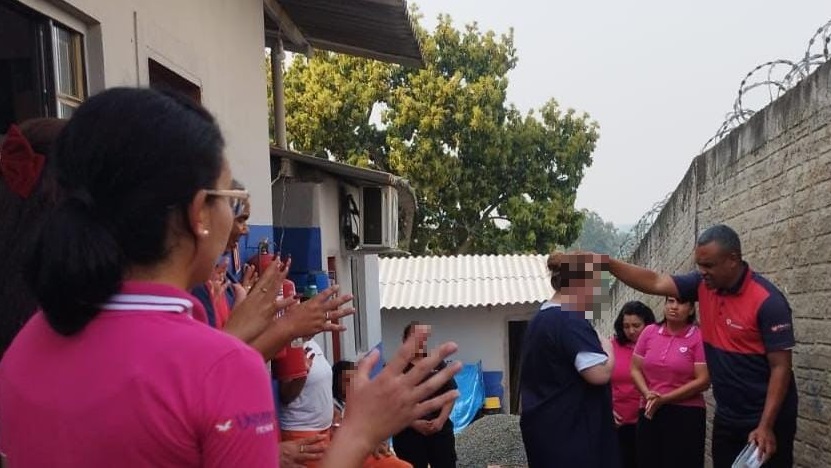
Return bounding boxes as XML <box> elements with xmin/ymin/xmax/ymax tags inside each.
<box><xmin>600</xmin><ymin>63</ymin><xmax>831</xmax><ymax>467</ymax></box>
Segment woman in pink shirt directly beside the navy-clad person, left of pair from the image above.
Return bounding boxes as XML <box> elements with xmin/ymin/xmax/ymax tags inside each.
<box><xmin>610</xmin><ymin>301</ymin><xmax>655</xmax><ymax>468</ymax></box>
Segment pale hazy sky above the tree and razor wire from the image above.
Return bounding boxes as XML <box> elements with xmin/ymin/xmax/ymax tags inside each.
<box><xmin>411</xmin><ymin>0</ymin><xmax>831</xmax><ymax>224</ymax></box>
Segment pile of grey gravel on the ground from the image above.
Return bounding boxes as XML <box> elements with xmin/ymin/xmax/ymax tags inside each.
<box><xmin>456</xmin><ymin>414</ymin><xmax>528</xmax><ymax>468</ymax></box>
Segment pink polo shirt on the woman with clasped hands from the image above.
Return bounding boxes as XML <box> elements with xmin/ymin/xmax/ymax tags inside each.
<box><xmin>634</xmin><ymin>324</ymin><xmax>706</xmax><ymax>408</ymax></box>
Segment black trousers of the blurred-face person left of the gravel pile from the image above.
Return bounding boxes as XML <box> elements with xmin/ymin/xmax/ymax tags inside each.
<box><xmin>392</xmin><ymin>420</ymin><xmax>456</xmax><ymax>468</ymax></box>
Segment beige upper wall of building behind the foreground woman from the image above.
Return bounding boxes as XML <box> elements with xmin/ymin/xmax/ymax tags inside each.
<box><xmin>21</xmin><ymin>0</ymin><xmax>271</xmax><ymax>225</ymax></box>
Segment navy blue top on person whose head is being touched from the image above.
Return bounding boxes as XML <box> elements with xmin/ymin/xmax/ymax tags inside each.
<box><xmin>520</xmin><ymin>304</ymin><xmax>619</xmax><ymax>468</ymax></box>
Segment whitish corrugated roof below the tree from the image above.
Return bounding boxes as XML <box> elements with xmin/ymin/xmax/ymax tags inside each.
<box><xmin>379</xmin><ymin>255</ymin><xmax>552</xmax><ymax>309</ymax></box>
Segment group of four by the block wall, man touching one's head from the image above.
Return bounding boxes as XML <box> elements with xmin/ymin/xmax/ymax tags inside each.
<box><xmin>520</xmin><ymin>224</ymin><xmax>798</xmax><ymax>468</ymax></box>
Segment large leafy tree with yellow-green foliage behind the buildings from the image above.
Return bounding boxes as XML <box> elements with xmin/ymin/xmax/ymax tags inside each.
<box><xmin>276</xmin><ymin>11</ymin><xmax>598</xmax><ymax>254</ymax></box>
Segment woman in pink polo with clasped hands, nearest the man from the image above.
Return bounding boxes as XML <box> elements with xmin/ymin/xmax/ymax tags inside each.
<box><xmin>632</xmin><ymin>297</ymin><xmax>710</xmax><ymax>468</ymax></box>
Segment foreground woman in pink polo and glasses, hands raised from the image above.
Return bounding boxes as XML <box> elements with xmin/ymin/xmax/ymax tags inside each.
<box><xmin>0</xmin><ymin>88</ymin><xmax>460</xmax><ymax>468</ymax></box>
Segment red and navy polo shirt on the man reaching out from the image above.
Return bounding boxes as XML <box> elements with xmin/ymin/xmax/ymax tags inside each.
<box><xmin>672</xmin><ymin>266</ymin><xmax>798</xmax><ymax>427</ymax></box>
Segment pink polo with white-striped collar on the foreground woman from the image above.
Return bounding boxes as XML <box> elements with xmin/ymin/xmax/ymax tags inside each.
<box><xmin>0</xmin><ymin>282</ymin><xmax>278</xmax><ymax>468</ymax></box>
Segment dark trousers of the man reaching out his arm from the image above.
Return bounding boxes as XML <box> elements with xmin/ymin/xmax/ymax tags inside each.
<box><xmin>712</xmin><ymin>416</ymin><xmax>796</xmax><ymax>468</ymax></box>
